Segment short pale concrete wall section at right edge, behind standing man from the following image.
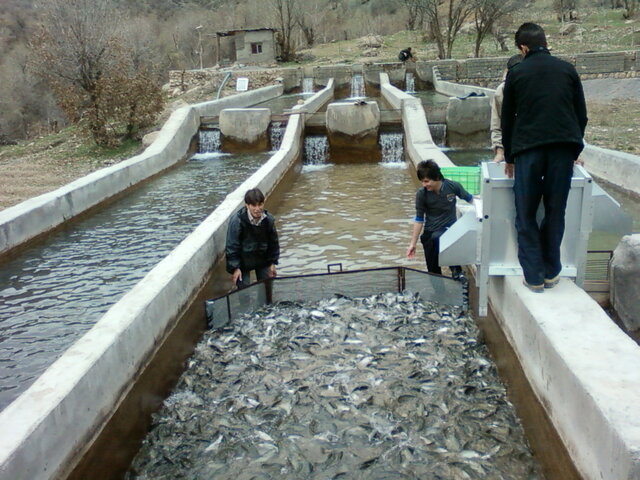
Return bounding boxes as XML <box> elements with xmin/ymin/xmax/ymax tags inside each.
<box><xmin>580</xmin><ymin>145</ymin><xmax>640</xmax><ymax>195</ymax></box>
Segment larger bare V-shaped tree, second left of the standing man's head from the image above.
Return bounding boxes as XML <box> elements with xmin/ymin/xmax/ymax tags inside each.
<box><xmin>419</xmin><ymin>0</ymin><xmax>475</xmax><ymax>58</ymax></box>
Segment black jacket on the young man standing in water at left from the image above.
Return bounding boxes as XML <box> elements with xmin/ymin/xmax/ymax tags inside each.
<box><xmin>225</xmin><ymin>207</ymin><xmax>280</xmax><ymax>273</ymax></box>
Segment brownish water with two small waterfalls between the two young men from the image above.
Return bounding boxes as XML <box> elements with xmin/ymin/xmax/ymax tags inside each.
<box><xmin>270</xmin><ymin>132</ymin><xmax>424</xmax><ymax>275</ymax></box>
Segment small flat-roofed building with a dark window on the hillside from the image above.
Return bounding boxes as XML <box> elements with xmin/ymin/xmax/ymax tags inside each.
<box><xmin>216</xmin><ymin>28</ymin><xmax>276</xmax><ymax>65</ymax></box>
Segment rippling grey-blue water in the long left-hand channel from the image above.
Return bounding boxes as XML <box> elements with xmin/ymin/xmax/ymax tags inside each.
<box><xmin>0</xmin><ymin>153</ymin><xmax>269</xmax><ymax>408</ymax></box>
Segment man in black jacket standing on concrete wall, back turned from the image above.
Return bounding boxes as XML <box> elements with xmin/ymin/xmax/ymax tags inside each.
<box><xmin>501</xmin><ymin>23</ymin><xmax>587</xmax><ymax>292</ymax></box>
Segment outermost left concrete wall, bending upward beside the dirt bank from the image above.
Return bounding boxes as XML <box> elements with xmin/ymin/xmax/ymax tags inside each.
<box><xmin>0</xmin><ymin>86</ymin><xmax>282</xmax><ymax>255</ymax></box>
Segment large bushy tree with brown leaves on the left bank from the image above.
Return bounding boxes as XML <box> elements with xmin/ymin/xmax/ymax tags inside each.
<box><xmin>31</xmin><ymin>0</ymin><xmax>162</xmax><ymax>146</ymax></box>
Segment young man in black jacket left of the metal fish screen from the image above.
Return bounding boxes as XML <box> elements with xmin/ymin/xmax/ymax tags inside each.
<box><xmin>225</xmin><ymin>188</ymin><xmax>280</xmax><ymax>287</ymax></box>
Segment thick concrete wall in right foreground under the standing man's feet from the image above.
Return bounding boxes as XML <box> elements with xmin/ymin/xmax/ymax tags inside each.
<box><xmin>489</xmin><ymin>276</ymin><xmax>640</xmax><ymax>480</ymax></box>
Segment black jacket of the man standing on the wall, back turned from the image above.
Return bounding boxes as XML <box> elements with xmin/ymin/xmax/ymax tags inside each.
<box><xmin>501</xmin><ymin>48</ymin><xmax>587</xmax><ymax>163</ymax></box>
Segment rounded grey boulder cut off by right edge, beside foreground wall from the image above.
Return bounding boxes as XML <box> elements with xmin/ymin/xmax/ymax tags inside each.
<box><xmin>609</xmin><ymin>234</ymin><xmax>640</xmax><ymax>331</ymax></box>
